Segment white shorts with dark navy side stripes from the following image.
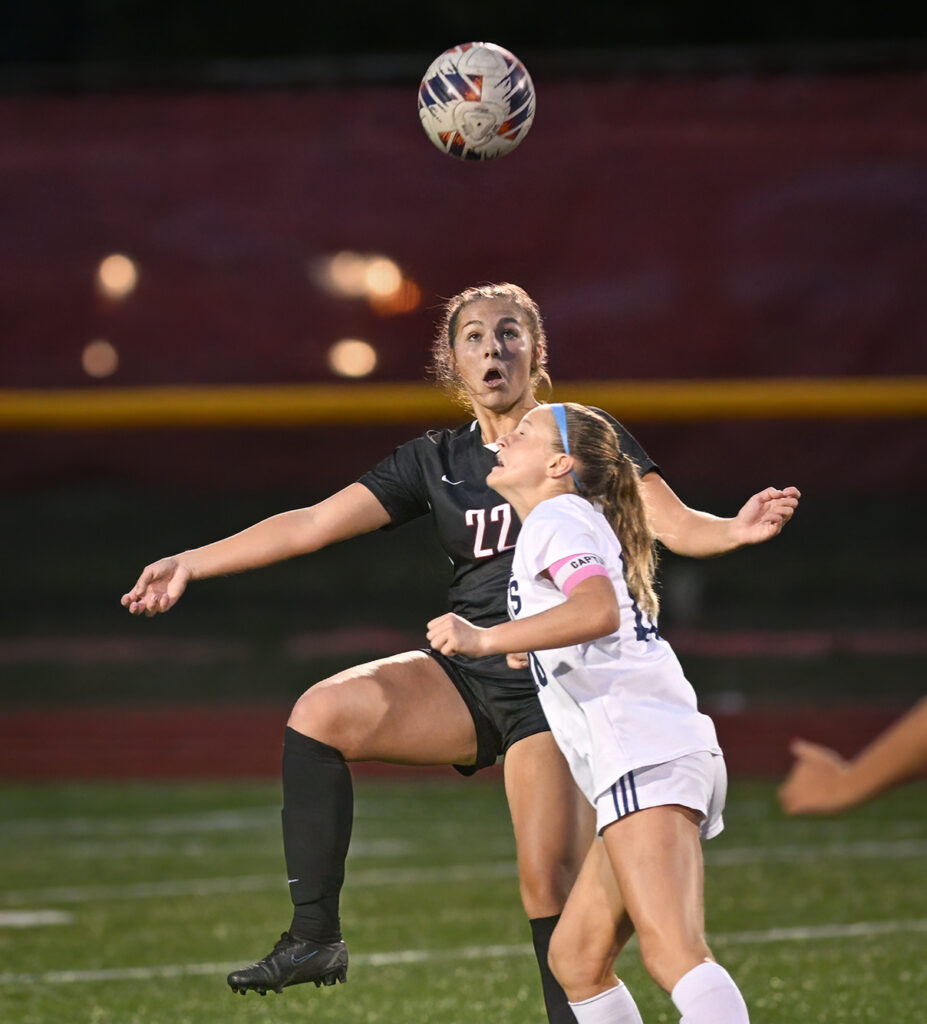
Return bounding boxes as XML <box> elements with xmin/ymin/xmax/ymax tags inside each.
<box><xmin>595</xmin><ymin>751</ymin><xmax>727</xmax><ymax>839</ymax></box>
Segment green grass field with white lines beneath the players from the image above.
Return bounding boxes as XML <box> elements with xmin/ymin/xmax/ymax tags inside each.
<box><xmin>0</xmin><ymin>778</ymin><xmax>927</xmax><ymax>1024</ymax></box>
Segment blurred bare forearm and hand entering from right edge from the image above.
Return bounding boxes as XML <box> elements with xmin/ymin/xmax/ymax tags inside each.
<box><xmin>778</xmin><ymin>697</ymin><xmax>927</xmax><ymax>814</ymax></box>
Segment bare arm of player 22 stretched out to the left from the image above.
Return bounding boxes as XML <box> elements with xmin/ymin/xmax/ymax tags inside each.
<box><xmin>122</xmin><ymin>483</ymin><xmax>389</xmax><ymax>616</ymax></box>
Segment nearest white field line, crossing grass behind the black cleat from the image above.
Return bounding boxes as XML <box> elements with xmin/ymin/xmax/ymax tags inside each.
<box><xmin>0</xmin><ymin>919</ymin><xmax>927</xmax><ymax>986</ymax></box>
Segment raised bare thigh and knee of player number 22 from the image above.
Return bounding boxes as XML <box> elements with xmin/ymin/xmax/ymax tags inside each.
<box><xmin>288</xmin><ymin>651</ymin><xmax>476</xmax><ymax>765</ymax></box>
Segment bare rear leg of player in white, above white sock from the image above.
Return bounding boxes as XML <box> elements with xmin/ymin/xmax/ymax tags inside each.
<box><xmin>550</xmin><ymin>842</ymin><xmax>634</xmax><ymax>1000</ymax></box>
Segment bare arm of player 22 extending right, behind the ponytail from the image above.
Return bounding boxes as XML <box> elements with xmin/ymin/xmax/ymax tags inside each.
<box><xmin>640</xmin><ymin>473</ymin><xmax>801</xmax><ymax>558</ymax></box>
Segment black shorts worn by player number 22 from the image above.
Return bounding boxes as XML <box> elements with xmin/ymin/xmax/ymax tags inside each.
<box><xmin>423</xmin><ymin>648</ymin><xmax>550</xmax><ymax>775</ymax></box>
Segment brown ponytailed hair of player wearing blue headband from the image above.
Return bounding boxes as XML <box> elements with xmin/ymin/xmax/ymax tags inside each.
<box><xmin>553</xmin><ymin>402</ymin><xmax>660</xmax><ymax>622</ymax></box>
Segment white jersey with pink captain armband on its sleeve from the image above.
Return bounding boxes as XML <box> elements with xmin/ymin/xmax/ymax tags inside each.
<box><xmin>508</xmin><ymin>495</ymin><xmax>721</xmax><ymax>804</ymax></box>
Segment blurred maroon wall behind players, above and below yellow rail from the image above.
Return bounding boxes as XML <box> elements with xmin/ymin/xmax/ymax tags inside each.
<box><xmin>0</xmin><ymin>74</ymin><xmax>927</xmax><ymax>490</ymax></box>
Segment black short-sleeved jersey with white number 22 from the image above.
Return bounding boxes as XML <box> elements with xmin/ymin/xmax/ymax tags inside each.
<box><xmin>360</xmin><ymin>410</ymin><xmax>659</xmax><ymax>679</ymax></box>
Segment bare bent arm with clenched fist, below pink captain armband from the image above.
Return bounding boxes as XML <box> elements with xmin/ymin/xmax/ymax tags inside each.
<box><xmin>428</xmin><ymin>575</ymin><xmax>621</xmax><ymax>657</ymax></box>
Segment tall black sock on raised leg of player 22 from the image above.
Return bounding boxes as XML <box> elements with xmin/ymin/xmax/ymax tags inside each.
<box><xmin>282</xmin><ymin>726</ymin><xmax>354</xmax><ymax>942</ymax></box>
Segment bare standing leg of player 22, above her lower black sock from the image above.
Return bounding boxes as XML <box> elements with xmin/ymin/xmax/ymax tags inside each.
<box><xmin>504</xmin><ymin>732</ymin><xmax>595</xmax><ymax>918</ymax></box>
